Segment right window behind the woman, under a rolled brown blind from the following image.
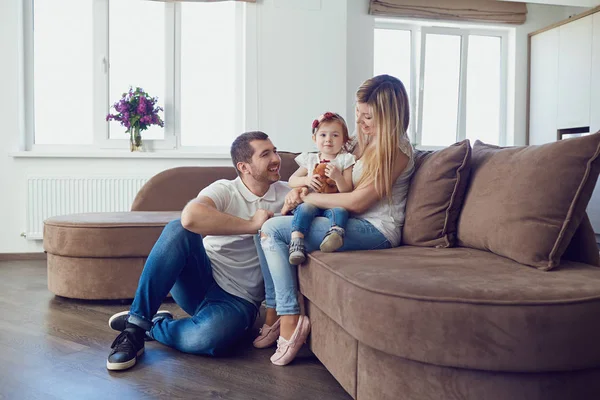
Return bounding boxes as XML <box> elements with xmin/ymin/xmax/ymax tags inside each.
<box><xmin>374</xmin><ymin>22</ymin><xmax>508</xmax><ymax>148</ymax></box>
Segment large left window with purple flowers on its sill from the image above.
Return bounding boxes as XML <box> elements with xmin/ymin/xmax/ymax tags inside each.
<box><xmin>24</xmin><ymin>0</ymin><xmax>245</xmax><ymax>152</ymax></box>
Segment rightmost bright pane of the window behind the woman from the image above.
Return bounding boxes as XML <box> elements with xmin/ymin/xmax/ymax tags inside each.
<box><xmin>467</xmin><ymin>35</ymin><xmax>502</xmax><ymax>144</ymax></box>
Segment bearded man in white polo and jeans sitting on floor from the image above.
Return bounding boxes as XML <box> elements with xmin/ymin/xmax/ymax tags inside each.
<box><xmin>106</xmin><ymin>132</ymin><xmax>289</xmax><ymax>370</ymax></box>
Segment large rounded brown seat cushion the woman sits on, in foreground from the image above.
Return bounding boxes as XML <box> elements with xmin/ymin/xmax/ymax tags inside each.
<box><xmin>298</xmin><ymin>246</ymin><xmax>600</xmax><ymax>372</ymax></box>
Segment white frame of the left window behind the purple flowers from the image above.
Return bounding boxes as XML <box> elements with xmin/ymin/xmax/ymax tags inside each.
<box><xmin>21</xmin><ymin>0</ymin><xmax>246</xmax><ymax>155</ymax></box>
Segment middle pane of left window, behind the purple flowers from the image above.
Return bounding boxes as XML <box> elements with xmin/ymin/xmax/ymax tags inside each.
<box><xmin>109</xmin><ymin>0</ymin><xmax>169</xmax><ymax>139</ymax></box>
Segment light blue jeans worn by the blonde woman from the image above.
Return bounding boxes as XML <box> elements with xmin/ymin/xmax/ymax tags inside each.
<box><xmin>256</xmin><ymin>216</ymin><xmax>391</xmax><ymax>315</ymax></box>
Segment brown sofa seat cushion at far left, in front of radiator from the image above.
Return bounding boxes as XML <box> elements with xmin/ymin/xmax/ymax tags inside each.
<box><xmin>44</xmin><ymin>211</ymin><xmax>181</xmax><ymax>258</ymax></box>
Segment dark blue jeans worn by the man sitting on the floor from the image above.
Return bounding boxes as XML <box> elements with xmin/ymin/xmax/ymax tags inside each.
<box><xmin>129</xmin><ymin>220</ymin><xmax>258</xmax><ymax>355</ymax></box>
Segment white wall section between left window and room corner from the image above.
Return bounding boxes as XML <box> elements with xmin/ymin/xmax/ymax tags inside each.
<box><xmin>257</xmin><ymin>0</ymin><xmax>347</xmax><ymax>151</ymax></box>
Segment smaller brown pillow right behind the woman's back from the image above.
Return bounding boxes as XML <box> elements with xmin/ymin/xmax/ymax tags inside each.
<box><xmin>402</xmin><ymin>140</ymin><xmax>471</xmax><ymax>247</ymax></box>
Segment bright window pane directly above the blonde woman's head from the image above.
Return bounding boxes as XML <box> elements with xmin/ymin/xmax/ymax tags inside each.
<box><xmin>373</xmin><ymin>29</ymin><xmax>411</xmax><ymax>95</ymax></box>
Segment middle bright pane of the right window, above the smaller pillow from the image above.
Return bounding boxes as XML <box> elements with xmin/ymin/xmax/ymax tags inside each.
<box><xmin>421</xmin><ymin>34</ymin><xmax>461</xmax><ymax>146</ymax></box>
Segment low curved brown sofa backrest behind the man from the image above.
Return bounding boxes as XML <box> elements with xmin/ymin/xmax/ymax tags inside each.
<box><xmin>131</xmin><ymin>152</ymin><xmax>298</xmax><ymax>211</ymax></box>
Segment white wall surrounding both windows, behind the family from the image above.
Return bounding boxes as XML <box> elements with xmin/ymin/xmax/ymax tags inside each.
<box><xmin>0</xmin><ymin>0</ymin><xmax>592</xmax><ymax>253</ymax></box>
